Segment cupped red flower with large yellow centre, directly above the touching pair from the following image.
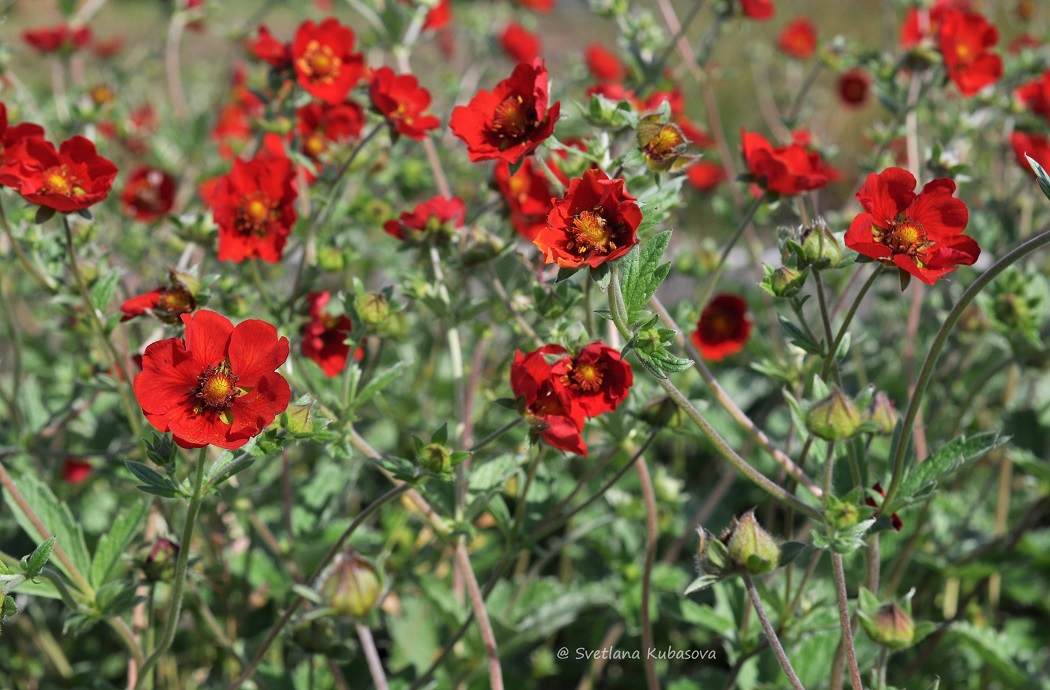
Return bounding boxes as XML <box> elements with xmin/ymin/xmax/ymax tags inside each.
<box><xmin>533</xmin><ymin>168</ymin><xmax>642</xmax><ymax>268</ymax></box>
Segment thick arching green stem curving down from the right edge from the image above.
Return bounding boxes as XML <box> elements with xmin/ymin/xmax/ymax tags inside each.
<box><xmin>882</xmin><ymin>230</ymin><xmax>1050</xmax><ymax>513</ymax></box>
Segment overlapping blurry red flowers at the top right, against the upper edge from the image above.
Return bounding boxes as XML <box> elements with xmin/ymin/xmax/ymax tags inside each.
<box><xmin>900</xmin><ymin>0</ymin><xmax>1003</xmax><ymax>96</ymax></box>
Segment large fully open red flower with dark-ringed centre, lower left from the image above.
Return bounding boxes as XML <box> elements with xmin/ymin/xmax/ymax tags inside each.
<box><xmin>134</xmin><ymin>310</ymin><xmax>292</xmax><ymax>449</ymax></box>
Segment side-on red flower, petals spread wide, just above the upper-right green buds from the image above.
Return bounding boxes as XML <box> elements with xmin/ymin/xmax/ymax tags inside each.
<box><xmin>740</xmin><ymin>129</ymin><xmax>840</xmax><ymax>194</ymax></box>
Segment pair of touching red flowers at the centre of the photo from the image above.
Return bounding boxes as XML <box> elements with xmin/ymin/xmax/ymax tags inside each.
<box><xmin>510</xmin><ymin>342</ymin><xmax>634</xmax><ymax>456</ymax></box>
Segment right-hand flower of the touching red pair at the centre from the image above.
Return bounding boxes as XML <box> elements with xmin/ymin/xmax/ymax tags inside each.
<box><xmin>550</xmin><ymin>342</ymin><xmax>634</xmax><ymax>417</ymax></box>
